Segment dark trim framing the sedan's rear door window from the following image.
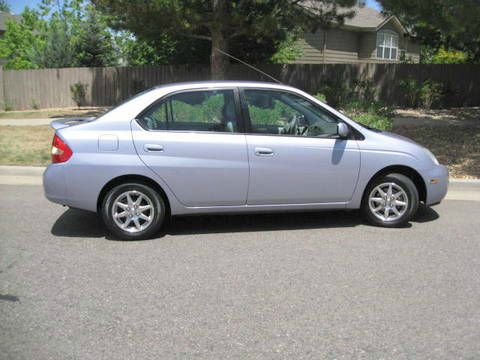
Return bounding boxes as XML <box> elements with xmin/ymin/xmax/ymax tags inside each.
<box><xmin>134</xmin><ymin>86</ymin><xmax>245</xmax><ymax>135</ymax></box>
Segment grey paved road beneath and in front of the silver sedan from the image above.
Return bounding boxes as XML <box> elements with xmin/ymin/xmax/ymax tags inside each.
<box><xmin>0</xmin><ymin>185</ymin><xmax>480</xmax><ymax>360</ymax></box>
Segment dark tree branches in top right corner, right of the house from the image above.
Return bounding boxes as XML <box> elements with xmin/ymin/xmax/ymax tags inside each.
<box><xmin>379</xmin><ymin>0</ymin><xmax>480</xmax><ymax>62</ymax></box>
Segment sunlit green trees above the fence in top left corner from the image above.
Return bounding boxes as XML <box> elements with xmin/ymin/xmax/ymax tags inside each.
<box><xmin>0</xmin><ymin>0</ymin><xmax>117</xmax><ymax>69</ymax></box>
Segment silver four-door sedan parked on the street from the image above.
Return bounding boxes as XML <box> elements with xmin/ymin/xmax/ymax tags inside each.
<box><xmin>44</xmin><ymin>82</ymin><xmax>448</xmax><ymax>239</ymax></box>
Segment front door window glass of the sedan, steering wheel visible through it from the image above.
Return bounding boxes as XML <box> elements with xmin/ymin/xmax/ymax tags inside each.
<box><xmin>244</xmin><ymin>90</ymin><xmax>338</xmax><ymax>137</ymax></box>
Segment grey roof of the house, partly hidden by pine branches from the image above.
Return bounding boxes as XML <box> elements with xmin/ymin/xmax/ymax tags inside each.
<box><xmin>302</xmin><ymin>0</ymin><xmax>408</xmax><ymax>33</ymax></box>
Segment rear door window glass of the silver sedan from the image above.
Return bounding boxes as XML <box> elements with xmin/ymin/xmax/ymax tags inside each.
<box><xmin>138</xmin><ymin>90</ymin><xmax>238</xmax><ymax>132</ymax></box>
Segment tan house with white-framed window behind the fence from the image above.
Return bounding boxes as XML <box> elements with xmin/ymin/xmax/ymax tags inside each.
<box><xmin>295</xmin><ymin>6</ymin><xmax>420</xmax><ymax>64</ymax></box>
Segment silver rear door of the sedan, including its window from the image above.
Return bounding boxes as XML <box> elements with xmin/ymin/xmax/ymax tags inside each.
<box><xmin>132</xmin><ymin>89</ymin><xmax>249</xmax><ymax>207</ymax></box>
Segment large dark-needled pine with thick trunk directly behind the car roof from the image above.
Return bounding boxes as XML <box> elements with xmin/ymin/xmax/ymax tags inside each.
<box><xmin>92</xmin><ymin>0</ymin><xmax>356</xmax><ymax>78</ymax></box>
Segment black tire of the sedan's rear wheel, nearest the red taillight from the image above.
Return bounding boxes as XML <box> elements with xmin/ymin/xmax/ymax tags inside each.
<box><xmin>101</xmin><ymin>182</ymin><xmax>166</xmax><ymax>240</ymax></box>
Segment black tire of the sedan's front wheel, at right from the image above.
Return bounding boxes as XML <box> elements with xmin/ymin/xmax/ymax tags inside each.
<box><xmin>362</xmin><ymin>173</ymin><xmax>419</xmax><ymax>228</ymax></box>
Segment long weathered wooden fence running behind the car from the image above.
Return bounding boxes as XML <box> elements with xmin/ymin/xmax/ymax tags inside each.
<box><xmin>0</xmin><ymin>64</ymin><xmax>480</xmax><ymax>110</ymax></box>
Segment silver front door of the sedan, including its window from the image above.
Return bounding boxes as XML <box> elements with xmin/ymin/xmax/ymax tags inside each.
<box><xmin>241</xmin><ymin>88</ymin><xmax>360</xmax><ymax>205</ymax></box>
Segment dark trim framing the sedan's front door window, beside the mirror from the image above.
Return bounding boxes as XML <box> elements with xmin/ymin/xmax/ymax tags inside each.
<box><xmin>239</xmin><ymin>87</ymin><xmax>365</xmax><ymax>141</ymax></box>
